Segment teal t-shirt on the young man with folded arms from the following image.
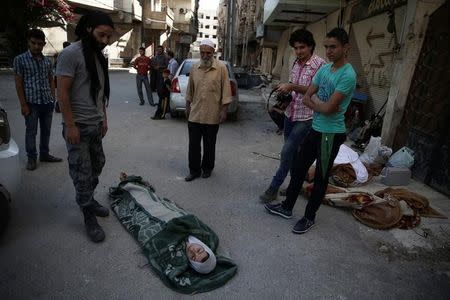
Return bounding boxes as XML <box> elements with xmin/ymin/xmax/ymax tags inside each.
<box><xmin>312</xmin><ymin>63</ymin><xmax>356</xmax><ymax>133</ymax></box>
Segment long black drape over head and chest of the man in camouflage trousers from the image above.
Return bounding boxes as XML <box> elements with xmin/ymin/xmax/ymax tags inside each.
<box><xmin>75</xmin><ymin>11</ymin><xmax>114</xmax><ymax>103</ymax></box>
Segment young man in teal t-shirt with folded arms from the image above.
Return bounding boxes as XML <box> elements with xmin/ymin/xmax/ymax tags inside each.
<box><xmin>265</xmin><ymin>28</ymin><xmax>356</xmax><ymax>233</ymax></box>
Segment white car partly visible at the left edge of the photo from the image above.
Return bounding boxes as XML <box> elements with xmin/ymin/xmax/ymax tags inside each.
<box><xmin>0</xmin><ymin>106</ymin><xmax>21</xmax><ymax>234</ymax></box>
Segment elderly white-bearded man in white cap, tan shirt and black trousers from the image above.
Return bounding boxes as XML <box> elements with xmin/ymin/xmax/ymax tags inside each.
<box><xmin>185</xmin><ymin>39</ymin><xmax>231</xmax><ymax>181</ymax></box>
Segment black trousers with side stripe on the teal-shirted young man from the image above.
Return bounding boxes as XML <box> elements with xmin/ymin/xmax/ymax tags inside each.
<box><xmin>282</xmin><ymin>129</ymin><xmax>346</xmax><ymax>221</ymax></box>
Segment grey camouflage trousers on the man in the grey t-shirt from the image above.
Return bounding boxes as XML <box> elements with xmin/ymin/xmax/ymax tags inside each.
<box><xmin>63</xmin><ymin>124</ymin><xmax>105</xmax><ymax>207</ymax></box>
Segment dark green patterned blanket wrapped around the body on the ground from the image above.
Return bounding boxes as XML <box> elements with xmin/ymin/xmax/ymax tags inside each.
<box><xmin>110</xmin><ymin>176</ymin><xmax>237</xmax><ymax>294</ymax></box>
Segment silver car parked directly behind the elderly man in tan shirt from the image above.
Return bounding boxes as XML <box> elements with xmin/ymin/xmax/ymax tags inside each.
<box><xmin>170</xmin><ymin>58</ymin><xmax>239</xmax><ymax>120</ymax></box>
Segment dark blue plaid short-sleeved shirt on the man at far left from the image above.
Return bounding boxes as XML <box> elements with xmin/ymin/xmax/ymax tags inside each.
<box><xmin>13</xmin><ymin>51</ymin><xmax>54</xmax><ymax>104</ymax></box>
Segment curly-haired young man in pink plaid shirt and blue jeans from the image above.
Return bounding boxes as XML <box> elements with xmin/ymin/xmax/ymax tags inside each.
<box><xmin>260</xmin><ymin>29</ymin><xmax>325</xmax><ymax>202</ymax></box>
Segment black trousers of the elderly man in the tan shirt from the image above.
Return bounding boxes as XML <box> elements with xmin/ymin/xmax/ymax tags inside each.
<box><xmin>188</xmin><ymin>122</ymin><xmax>219</xmax><ymax>175</ymax></box>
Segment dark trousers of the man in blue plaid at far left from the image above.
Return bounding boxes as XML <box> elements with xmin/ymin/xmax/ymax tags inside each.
<box><xmin>25</xmin><ymin>103</ymin><xmax>54</xmax><ymax>159</ymax></box>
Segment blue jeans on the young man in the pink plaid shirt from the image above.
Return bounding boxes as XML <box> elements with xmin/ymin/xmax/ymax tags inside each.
<box><xmin>270</xmin><ymin>117</ymin><xmax>312</xmax><ymax>189</ymax></box>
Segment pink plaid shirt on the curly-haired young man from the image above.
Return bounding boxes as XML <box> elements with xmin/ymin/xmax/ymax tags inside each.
<box><xmin>285</xmin><ymin>54</ymin><xmax>325</xmax><ymax>122</ymax></box>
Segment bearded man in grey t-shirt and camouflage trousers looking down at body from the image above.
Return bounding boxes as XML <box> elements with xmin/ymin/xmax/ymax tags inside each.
<box><xmin>56</xmin><ymin>12</ymin><xmax>114</xmax><ymax>242</ymax></box>
